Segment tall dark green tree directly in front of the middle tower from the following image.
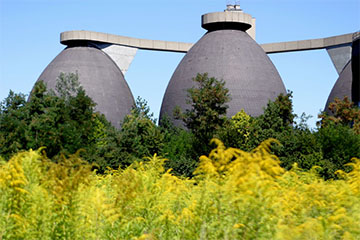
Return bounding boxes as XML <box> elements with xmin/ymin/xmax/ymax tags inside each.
<box><xmin>175</xmin><ymin>73</ymin><xmax>230</xmax><ymax>153</ymax></box>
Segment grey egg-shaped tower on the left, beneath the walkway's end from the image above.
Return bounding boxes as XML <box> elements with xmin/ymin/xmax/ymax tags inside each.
<box><xmin>38</xmin><ymin>42</ymin><xmax>134</xmax><ymax>128</ymax></box>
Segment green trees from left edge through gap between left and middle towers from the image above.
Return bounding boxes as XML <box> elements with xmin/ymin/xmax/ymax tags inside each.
<box><xmin>0</xmin><ymin>76</ymin><xmax>163</xmax><ymax>172</ymax></box>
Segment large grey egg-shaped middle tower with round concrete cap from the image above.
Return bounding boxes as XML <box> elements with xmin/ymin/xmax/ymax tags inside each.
<box><xmin>160</xmin><ymin>11</ymin><xmax>286</xmax><ymax>126</ymax></box>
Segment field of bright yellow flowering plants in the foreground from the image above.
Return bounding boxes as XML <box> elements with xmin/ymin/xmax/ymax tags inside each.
<box><xmin>0</xmin><ymin>140</ymin><xmax>360</xmax><ymax>239</ymax></box>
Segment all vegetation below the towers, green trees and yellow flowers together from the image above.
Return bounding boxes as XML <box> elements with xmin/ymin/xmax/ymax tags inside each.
<box><xmin>0</xmin><ymin>74</ymin><xmax>360</xmax><ymax>239</ymax></box>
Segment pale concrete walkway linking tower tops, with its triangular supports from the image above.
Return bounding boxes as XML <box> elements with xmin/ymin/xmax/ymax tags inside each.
<box><xmin>60</xmin><ymin>30</ymin><xmax>354</xmax><ymax>74</ymax></box>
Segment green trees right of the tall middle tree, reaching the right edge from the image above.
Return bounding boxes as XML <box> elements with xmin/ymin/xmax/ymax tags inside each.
<box><xmin>219</xmin><ymin>92</ymin><xmax>360</xmax><ymax>179</ymax></box>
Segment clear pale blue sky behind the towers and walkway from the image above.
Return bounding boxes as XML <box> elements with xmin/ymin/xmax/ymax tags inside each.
<box><xmin>0</xmin><ymin>0</ymin><xmax>360</xmax><ymax>127</ymax></box>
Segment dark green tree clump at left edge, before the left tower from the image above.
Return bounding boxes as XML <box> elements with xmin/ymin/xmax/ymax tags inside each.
<box><xmin>0</xmin><ymin>73</ymin><xmax>102</xmax><ymax>159</ymax></box>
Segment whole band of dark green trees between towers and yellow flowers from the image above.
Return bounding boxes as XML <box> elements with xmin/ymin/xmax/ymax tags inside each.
<box><xmin>0</xmin><ymin>74</ymin><xmax>360</xmax><ymax>179</ymax></box>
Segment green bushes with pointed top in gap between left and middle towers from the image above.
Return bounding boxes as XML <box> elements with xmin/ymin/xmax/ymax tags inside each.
<box><xmin>87</xmin><ymin>97</ymin><xmax>164</xmax><ymax>172</ymax></box>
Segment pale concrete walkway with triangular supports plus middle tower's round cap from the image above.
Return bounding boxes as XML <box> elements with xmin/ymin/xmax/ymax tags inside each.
<box><xmin>60</xmin><ymin>31</ymin><xmax>353</xmax><ymax>80</ymax></box>
